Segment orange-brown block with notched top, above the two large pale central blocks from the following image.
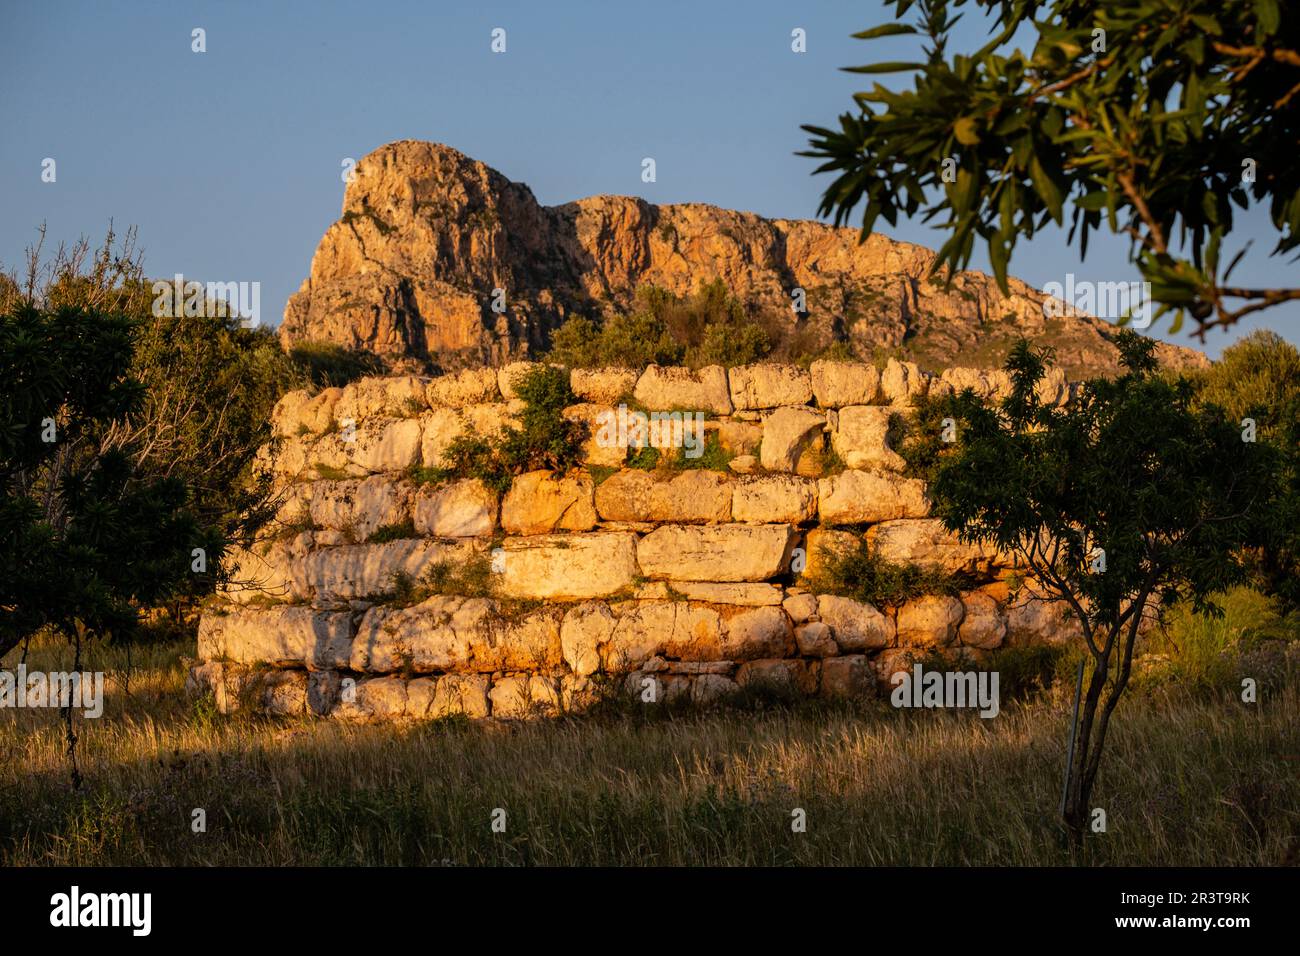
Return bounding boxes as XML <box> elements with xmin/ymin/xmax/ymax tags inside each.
<box><xmin>595</xmin><ymin>468</ymin><xmax>732</xmax><ymax>524</ymax></box>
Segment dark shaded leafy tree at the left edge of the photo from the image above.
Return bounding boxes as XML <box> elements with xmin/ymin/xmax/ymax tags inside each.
<box><xmin>0</xmin><ymin>304</ymin><xmax>224</xmax><ymax>656</ymax></box>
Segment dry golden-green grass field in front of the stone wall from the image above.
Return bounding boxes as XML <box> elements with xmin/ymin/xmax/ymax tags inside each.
<box><xmin>0</xmin><ymin>629</ymin><xmax>1300</xmax><ymax>865</ymax></box>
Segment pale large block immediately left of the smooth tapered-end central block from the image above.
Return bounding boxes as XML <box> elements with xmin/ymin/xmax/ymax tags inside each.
<box><xmin>502</xmin><ymin>532</ymin><xmax>638</xmax><ymax>601</ymax></box>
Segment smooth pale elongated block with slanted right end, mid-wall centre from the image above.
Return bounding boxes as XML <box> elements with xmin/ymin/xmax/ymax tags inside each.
<box><xmin>637</xmin><ymin>524</ymin><xmax>794</xmax><ymax>581</ymax></box>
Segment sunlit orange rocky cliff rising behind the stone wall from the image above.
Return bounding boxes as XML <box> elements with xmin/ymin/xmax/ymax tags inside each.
<box><xmin>281</xmin><ymin>140</ymin><xmax>1205</xmax><ymax>377</ymax></box>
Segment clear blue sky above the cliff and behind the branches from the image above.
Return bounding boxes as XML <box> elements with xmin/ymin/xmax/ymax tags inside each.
<box><xmin>0</xmin><ymin>0</ymin><xmax>1300</xmax><ymax>355</ymax></box>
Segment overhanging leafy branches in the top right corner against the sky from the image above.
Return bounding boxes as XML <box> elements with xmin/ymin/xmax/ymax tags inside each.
<box><xmin>803</xmin><ymin>0</ymin><xmax>1300</xmax><ymax>341</ymax></box>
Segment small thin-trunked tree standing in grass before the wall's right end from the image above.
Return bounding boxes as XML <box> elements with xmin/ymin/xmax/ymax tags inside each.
<box><xmin>930</xmin><ymin>329</ymin><xmax>1277</xmax><ymax>842</ymax></box>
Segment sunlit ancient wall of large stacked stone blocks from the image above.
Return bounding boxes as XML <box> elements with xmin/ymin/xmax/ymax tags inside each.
<box><xmin>191</xmin><ymin>362</ymin><xmax>1071</xmax><ymax>719</ymax></box>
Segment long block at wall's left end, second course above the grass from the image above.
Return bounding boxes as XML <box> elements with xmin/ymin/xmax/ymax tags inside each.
<box><xmin>199</xmin><ymin>605</ymin><xmax>352</xmax><ymax>669</ymax></box>
